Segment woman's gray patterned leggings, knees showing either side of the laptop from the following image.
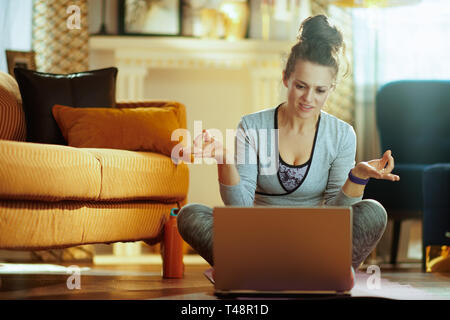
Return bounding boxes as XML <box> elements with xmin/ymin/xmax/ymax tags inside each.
<box><xmin>177</xmin><ymin>199</ymin><xmax>387</xmax><ymax>270</ymax></box>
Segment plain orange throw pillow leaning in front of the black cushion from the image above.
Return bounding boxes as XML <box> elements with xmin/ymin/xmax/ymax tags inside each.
<box><xmin>52</xmin><ymin>105</ymin><xmax>180</xmax><ymax>157</ymax></box>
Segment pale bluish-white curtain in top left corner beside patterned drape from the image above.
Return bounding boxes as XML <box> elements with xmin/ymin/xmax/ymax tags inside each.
<box><xmin>0</xmin><ymin>0</ymin><xmax>33</xmax><ymax>73</ymax></box>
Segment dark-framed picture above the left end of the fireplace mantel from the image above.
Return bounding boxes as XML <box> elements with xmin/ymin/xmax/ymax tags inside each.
<box><xmin>118</xmin><ymin>0</ymin><xmax>181</xmax><ymax>36</ymax></box>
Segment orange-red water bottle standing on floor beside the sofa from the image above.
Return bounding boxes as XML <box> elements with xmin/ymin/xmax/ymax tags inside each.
<box><xmin>163</xmin><ymin>208</ymin><xmax>184</xmax><ymax>279</ymax></box>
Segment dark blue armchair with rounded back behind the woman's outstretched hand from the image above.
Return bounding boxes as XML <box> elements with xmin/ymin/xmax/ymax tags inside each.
<box><xmin>364</xmin><ymin>80</ymin><xmax>450</xmax><ymax>264</ymax></box>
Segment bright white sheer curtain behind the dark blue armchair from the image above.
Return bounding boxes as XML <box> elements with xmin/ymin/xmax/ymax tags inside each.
<box><xmin>352</xmin><ymin>0</ymin><xmax>450</xmax><ymax>161</ymax></box>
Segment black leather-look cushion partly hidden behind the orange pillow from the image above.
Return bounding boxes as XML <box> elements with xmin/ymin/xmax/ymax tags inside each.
<box><xmin>14</xmin><ymin>68</ymin><xmax>117</xmax><ymax>145</ymax></box>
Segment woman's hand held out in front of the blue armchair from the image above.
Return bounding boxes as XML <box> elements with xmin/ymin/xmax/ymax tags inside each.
<box><xmin>352</xmin><ymin>150</ymin><xmax>400</xmax><ymax>181</ymax></box>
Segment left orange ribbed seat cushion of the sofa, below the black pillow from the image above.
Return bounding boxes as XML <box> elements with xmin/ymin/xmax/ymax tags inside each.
<box><xmin>0</xmin><ymin>140</ymin><xmax>101</xmax><ymax>201</ymax></box>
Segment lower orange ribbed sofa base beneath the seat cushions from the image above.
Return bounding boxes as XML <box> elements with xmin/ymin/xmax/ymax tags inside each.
<box><xmin>0</xmin><ymin>200</ymin><xmax>177</xmax><ymax>250</ymax></box>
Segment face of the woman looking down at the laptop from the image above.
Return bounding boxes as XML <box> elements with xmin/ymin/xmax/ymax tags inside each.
<box><xmin>283</xmin><ymin>60</ymin><xmax>335</xmax><ymax>119</ymax></box>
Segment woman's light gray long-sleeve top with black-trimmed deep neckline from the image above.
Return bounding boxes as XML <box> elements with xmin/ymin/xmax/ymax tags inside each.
<box><xmin>219</xmin><ymin>107</ymin><xmax>362</xmax><ymax>207</ymax></box>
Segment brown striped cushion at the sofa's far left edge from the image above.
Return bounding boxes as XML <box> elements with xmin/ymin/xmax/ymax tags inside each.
<box><xmin>0</xmin><ymin>71</ymin><xmax>26</xmax><ymax>141</ymax></box>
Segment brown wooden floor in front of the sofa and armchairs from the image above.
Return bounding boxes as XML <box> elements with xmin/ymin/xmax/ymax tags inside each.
<box><xmin>0</xmin><ymin>263</ymin><xmax>450</xmax><ymax>300</ymax></box>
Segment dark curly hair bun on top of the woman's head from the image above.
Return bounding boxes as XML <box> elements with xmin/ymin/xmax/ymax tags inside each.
<box><xmin>298</xmin><ymin>15</ymin><xmax>343</xmax><ymax>51</ymax></box>
